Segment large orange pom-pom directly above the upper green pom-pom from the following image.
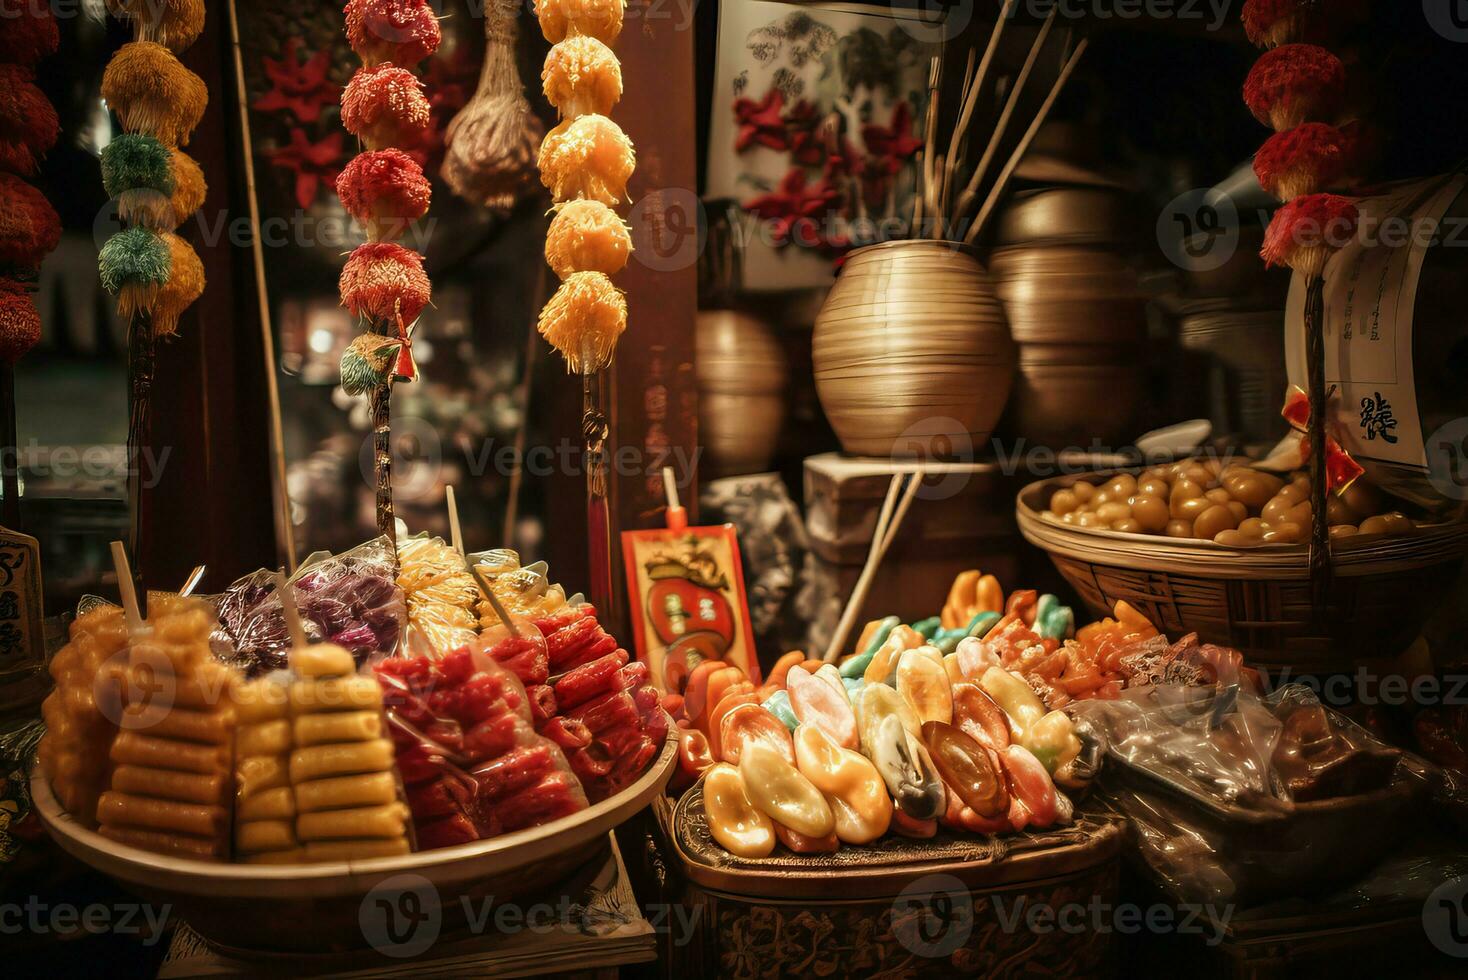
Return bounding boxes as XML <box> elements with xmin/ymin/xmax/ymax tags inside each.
<box><xmin>101</xmin><ymin>41</ymin><xmax>208</xmax><ymax>147</ymax></box>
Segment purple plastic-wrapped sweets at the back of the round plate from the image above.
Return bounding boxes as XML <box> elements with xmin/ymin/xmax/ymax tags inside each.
<box><xmin>216</xmin><ymin>537</ymin><xmax>408</xmax><ymax>676</ymax></box>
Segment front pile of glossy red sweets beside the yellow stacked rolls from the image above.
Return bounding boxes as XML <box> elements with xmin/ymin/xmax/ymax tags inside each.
<box><xmin>376</xmin><ymin>648</ymin><xmax>587</xmax><ymax>848</ymax></box>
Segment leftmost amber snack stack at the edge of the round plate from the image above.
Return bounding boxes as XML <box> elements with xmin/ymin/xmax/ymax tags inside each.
<box><xmin>38</xmin><ymin>606</ymin><xmax>128</xmax><ymax>827</ymax></box>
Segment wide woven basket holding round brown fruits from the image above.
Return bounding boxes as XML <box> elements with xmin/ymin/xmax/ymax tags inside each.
<box><xmin>1016</xmin><ymin>469</ymin><xmax>1468</xmax><ymax>673</ymax></box>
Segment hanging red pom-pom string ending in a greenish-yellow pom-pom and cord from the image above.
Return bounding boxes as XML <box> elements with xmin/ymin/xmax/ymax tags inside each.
<box><xmin>336</xmin><ymin>0</ymin><xmax>442</xmax><ymax>540</ymax></box>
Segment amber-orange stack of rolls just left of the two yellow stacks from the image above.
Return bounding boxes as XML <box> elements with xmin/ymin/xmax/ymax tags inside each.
<box><xmin>97</xmin><ymin>599</ymin><xmax>239</xmax><ymax>860</ymax></box>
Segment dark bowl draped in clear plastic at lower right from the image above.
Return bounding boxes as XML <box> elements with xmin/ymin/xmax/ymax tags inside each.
<box><xmin>1067</xmin><ymin>680</ymin><xmax>1430</xmax><ymax>905</ymax></box>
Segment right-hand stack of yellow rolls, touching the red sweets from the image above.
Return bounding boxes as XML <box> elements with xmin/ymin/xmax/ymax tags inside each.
<box><xmin>291</xmin><ymin>644</ymin><xmax>410</xmax><ymax>861</ymax></box>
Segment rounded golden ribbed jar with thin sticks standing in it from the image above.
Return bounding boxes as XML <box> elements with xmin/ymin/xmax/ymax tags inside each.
<box><xmin>812</xmin><ymin>241</ymin><xmax>1014</xmax><ymax>456</ymax></box>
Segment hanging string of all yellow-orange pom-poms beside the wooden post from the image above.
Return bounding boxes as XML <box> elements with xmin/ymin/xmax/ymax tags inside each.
<box><xmin>536</xmin><ymin>0</ymin><xmax>636</xmax><ymax>374</ymax></box>
